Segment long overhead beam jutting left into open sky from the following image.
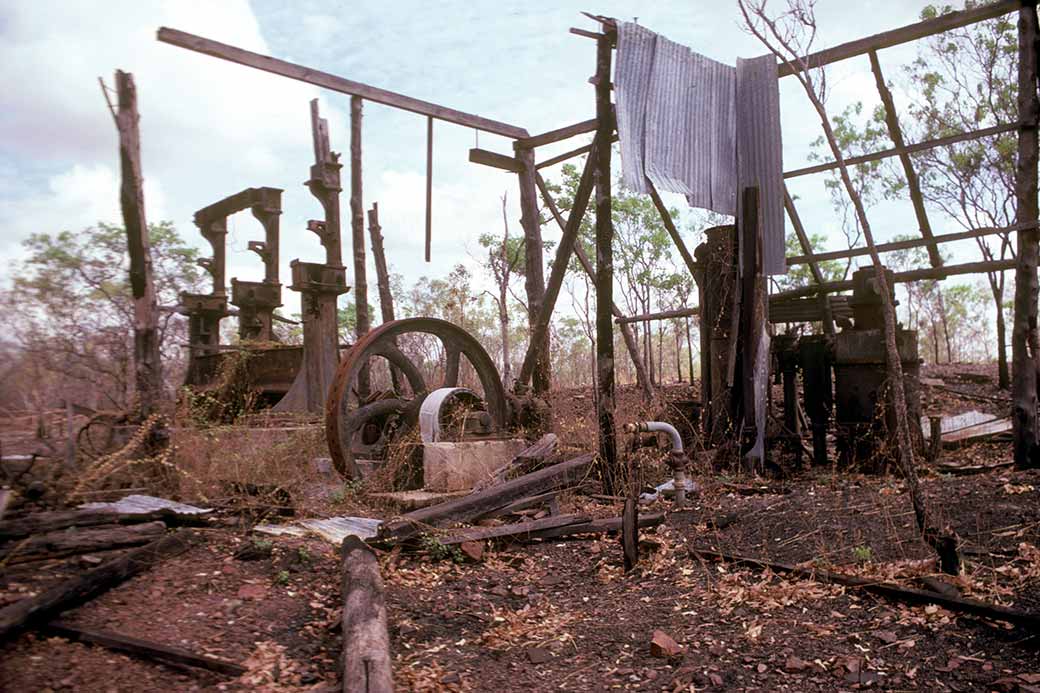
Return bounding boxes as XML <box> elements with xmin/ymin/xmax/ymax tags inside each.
<box><xmin>157</xmin><ymin>27</ymin><xmax>530</xmax><ymax>139</ymax></box>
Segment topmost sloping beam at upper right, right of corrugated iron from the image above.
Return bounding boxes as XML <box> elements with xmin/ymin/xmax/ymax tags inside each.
<box><xmin>778</xmin><ymin>0</ymin><xmax>1021</xmax><ymax>77</ymax></box>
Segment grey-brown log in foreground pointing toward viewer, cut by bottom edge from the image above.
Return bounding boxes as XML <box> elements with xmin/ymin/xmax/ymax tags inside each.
<box><xmin>342</xmin><ymin>535</ymin><xmax>393</xmax><ymax>693</ymax></box>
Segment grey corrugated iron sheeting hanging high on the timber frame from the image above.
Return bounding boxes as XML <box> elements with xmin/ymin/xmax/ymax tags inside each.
<box><xmin>615</xmin><ymin>22</ymin><xmax>787</xmax><ymax>275</ymax></box>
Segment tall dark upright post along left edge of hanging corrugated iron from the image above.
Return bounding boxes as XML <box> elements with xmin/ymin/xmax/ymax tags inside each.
<box><xmin>594</xmin><ymin>32</ymin><xmax>624</xmax><ymax>495</ymax></box>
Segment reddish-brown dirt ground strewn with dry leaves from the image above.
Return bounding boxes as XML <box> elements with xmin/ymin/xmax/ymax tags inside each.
<box><xmin>0</xmin><ymin>366</ymin><xmax>1040</xmax><ymax>691</ymax></box>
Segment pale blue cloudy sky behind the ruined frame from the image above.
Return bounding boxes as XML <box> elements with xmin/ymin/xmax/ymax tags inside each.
<box><xmin>0</xmin><ymin>0</ymin><xmax>981</xmax><ymax>312</ymax></box>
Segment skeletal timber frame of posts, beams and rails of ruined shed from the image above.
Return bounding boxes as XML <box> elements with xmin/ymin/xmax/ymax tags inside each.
<box><xmin>158</xmin><ymin>0</ymin><xmax>1040</xmax><ymax>469</ymax></box>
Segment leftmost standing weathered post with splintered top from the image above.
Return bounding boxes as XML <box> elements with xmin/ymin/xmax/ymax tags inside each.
<box><xmin>115</xmin><ymin>70</ymin><xmax>162</xmax><ymax>420</ymax></box>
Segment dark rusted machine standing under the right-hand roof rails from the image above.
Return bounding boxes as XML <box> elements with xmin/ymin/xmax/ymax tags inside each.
<box><xmin>776</xmin><ymin>267</ymin><xmax>920</xmax><ymax>470</ymax></box>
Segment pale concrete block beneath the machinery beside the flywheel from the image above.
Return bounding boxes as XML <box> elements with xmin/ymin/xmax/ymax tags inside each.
<box><xmin>422</xmin><ymin>439</ymin><xmax>527</xmax><ymax>493</ymax></box>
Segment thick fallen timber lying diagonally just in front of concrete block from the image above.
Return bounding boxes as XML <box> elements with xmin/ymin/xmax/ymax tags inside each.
<box><xmin>378</xmin><ymin>454</ymin><xmax>594</xmax><ymax>543</ymax></box>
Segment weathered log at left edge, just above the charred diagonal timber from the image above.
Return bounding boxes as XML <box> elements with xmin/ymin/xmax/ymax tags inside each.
<box><xmin>0</xmin><ymin>520</ymin><xmax>166</xmax><ymax>565</ymax></box>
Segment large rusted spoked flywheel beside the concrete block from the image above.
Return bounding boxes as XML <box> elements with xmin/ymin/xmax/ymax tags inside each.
<box><xmin>326</xmin><ymin>317</ymin><xmax>508</xmax><ymax>479</ymax></box>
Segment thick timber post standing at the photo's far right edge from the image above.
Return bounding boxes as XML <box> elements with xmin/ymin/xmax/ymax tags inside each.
<box><xmin>1011</xmin><ymin>0</ymin><xmax>1040</xmax><ymax>469</ymax></box>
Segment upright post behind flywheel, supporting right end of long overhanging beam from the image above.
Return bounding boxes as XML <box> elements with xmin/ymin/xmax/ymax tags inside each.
<box><xmin>517</xmin><ymin>149</ymin><xmax>553</xmax><ymax>394</ymax></box>
